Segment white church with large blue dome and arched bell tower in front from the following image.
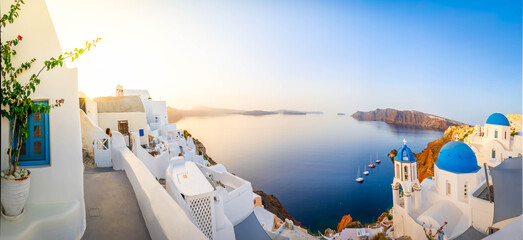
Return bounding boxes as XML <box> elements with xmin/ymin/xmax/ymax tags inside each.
<box><xmin>392</xmin><ymin>141</ymin><xmax>521</xmax><ymax>239</ymax></box>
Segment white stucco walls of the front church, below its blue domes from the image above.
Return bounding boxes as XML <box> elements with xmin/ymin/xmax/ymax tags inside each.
<box><xmin>393</xmin><ymin>153</ymin><xmax>489</xmax><ymax>239</ymax></box>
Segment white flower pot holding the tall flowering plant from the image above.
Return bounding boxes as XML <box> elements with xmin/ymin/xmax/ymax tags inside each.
<box><xmin>1</xmin><ymin>170</ymin><xmax>31</xmax><ymax>220</ymax></box>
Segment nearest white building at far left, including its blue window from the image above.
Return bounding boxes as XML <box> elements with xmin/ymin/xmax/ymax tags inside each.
<box><xmin>0</xmin><ymin>0</ymin><xmax>86</xmax><ymax>239</ymax></box>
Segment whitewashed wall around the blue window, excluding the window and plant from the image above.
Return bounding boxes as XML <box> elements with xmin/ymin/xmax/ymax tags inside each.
<box><xmin>0</xmin><ymin>0</ymin><xmax>85</xmax><ymax>239</ymax></box>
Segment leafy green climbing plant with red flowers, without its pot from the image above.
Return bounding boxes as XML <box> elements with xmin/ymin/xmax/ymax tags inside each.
<box><xmin>0</xmin><ymin>0</ymin><xmax>101</xmax><ymax>175</ymax></box>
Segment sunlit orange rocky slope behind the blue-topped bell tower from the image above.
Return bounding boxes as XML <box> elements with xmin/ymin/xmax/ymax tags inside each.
<box><xmin>414</xmin><ymin>125</ymin><xmax>474</xmax><ymax>182</ymax></box>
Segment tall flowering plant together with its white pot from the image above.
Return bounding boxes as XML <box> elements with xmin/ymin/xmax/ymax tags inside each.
<box><xmin>0</xmin><ymin>0</ymin><xmax>100</xmax><ymax>220</ymax></box>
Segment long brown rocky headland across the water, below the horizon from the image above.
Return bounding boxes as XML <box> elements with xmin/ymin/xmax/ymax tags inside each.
<box><xmin>352</xmin><ymin>108</ymin><xmax>464</xmax><ymax>131</ymax></box>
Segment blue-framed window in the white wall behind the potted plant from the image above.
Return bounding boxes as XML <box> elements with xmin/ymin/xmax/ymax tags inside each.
<box><xmin>15</xmin><ymin>101</ymin><xmax>50</xmax><ymax>166</ymax></box>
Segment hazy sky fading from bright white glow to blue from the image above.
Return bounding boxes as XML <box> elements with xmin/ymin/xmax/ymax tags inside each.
<box><xmin>44</xmin><ymin>0</ymin><xmax>522</xmax><ymax>124</ymax></box>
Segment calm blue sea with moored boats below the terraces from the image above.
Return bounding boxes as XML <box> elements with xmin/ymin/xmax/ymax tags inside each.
<box><xmin>178</xmin><ymin>114</ymin><xmax>443</xmax><ymax>232</ymax></box>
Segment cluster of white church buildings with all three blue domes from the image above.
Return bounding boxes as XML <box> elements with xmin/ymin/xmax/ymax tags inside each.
<box><xmin>392</xmin><ymin>113</ymin><xmax>522</xmax><ymax>239</ymax></box>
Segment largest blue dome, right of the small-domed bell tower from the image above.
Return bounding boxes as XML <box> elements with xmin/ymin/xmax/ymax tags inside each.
<box><xmin>436</xmin><ymin>141</ymin><xmax>481</xmax><ymax>173</ymax></box>
